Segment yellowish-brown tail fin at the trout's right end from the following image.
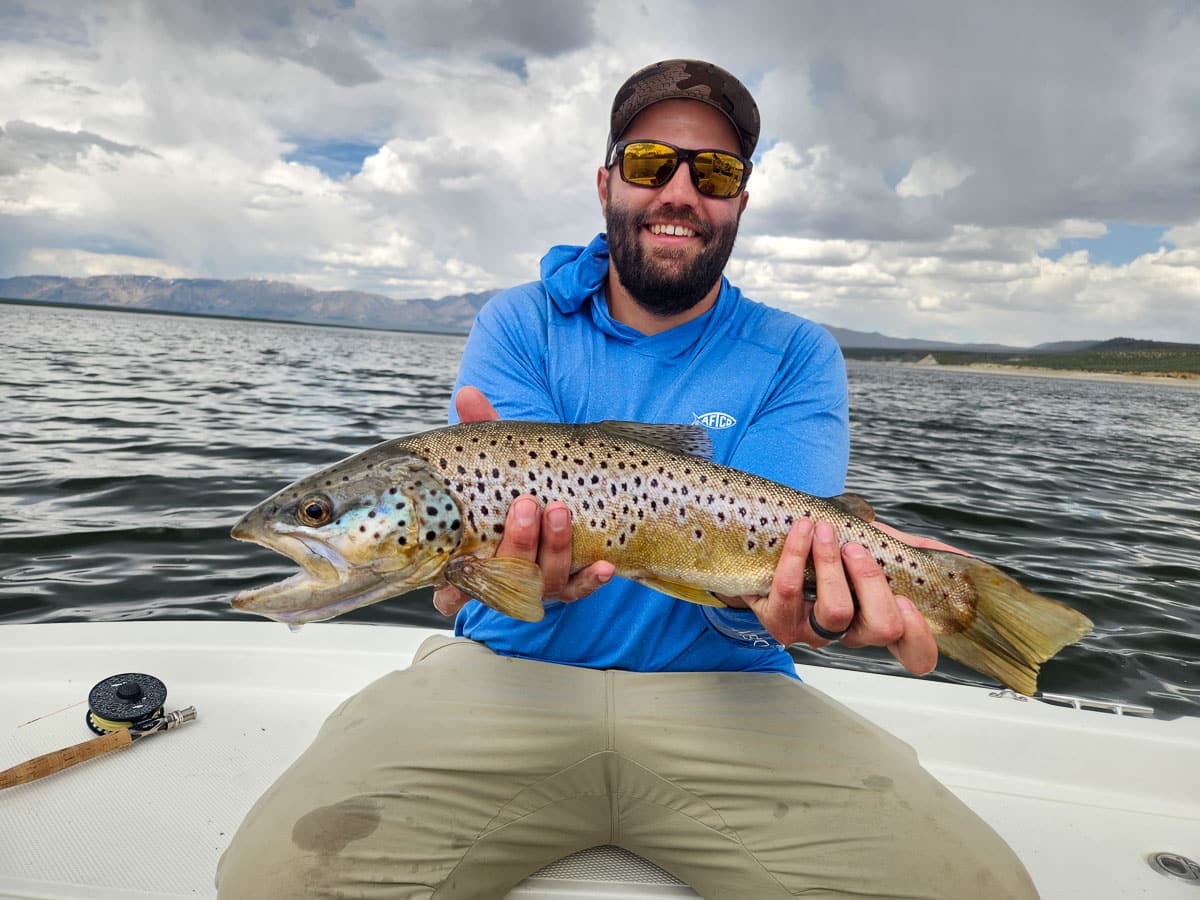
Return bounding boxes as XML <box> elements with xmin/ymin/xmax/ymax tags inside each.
<box><xmin>925</xmin><ymin>550</ymin><xmax>1092</xmax><ymax>695</ymax></box>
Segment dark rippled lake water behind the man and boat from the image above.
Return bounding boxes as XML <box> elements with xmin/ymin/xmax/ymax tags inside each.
<box><xmin>0</xmin><ymin>304</ymin><xmax>1200</xmax><ymax>715</ymax></box>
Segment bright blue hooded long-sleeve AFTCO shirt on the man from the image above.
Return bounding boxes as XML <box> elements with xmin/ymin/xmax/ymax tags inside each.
<box><xmin>450</xmin><ymin>235</ymin><xmax>850</xmax><ymax>676</ymax></box>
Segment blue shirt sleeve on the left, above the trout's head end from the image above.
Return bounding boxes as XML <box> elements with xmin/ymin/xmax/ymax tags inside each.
<box><xmin>449</xmin><ymin>283</ymin><xmax>559</xmax><ymax>425</ymax></box>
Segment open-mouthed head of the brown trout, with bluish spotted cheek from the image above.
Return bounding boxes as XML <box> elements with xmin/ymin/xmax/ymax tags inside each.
<box><xmin>233</xmin><ymin>444</ymin><xmax>463</xmax><ymax>625</ymax></box>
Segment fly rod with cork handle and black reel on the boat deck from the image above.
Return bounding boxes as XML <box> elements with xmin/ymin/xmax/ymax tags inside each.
<box><xmin>0</xmin><ymin>672</ymin><xmax>196</xmax><ymax>790</ymax></box>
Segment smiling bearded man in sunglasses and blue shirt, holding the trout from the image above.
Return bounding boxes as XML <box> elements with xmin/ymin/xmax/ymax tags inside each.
<box><xmin>218</xmin><ymin>60</ymin><xmax>1036</xmax><ymax>900</ymax></box>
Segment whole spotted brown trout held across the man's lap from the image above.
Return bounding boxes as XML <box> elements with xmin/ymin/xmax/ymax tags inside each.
<box><xmin>233</xmin><ymin>420</ymin><xmax>1092</xmax><ymax>694</ymax></box>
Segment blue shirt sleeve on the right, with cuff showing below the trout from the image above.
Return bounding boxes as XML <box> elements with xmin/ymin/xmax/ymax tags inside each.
<box><xmin>701</xmin><ymin>325</ymin><xmax>850</xmax><ymax>650</ymax></box>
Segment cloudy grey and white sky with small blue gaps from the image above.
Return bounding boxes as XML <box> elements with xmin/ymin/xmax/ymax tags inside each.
<box><xmin>0</xmin><ymin>0</ymin><xmax>1200</xmax><ymax>344</ymax></box>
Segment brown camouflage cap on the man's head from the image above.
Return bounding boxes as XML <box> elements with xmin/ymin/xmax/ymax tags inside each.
<box><xmin>605</xmin><ymin>59</ymin><xmax>758</xmax><ymax>162</ymax></box>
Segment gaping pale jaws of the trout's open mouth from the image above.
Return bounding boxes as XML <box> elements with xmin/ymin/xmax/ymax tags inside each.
<box><xmin>230</xmin><ymin>521</ymin><xmax>396</xmax><ymax>625</ymax></box>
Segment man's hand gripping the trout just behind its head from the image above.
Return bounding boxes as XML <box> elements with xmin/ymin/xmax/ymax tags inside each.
<box><xmin>433</xmin><ymin>388</ymin><xmax>616</xmax><ymax>616</ymax></box>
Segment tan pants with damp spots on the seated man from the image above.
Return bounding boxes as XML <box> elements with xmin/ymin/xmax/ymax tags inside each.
<box><xmin>217</xmin><ymin>637</ymin><xmax>1037</xmax><ymax>900</ymax></box>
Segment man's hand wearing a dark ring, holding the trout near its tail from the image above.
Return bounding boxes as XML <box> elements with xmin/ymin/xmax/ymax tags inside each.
<box><xmin>726</xmin><ymin>518</ymin><xmax>954</xmax><ymax>674</ymax></box>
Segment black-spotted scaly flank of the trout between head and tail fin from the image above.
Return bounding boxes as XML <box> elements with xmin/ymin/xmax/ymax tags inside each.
<box><xmin>396</xmin><ymin>420</ymin><xmax>971</xmax><ymax>632</ymax></box>
